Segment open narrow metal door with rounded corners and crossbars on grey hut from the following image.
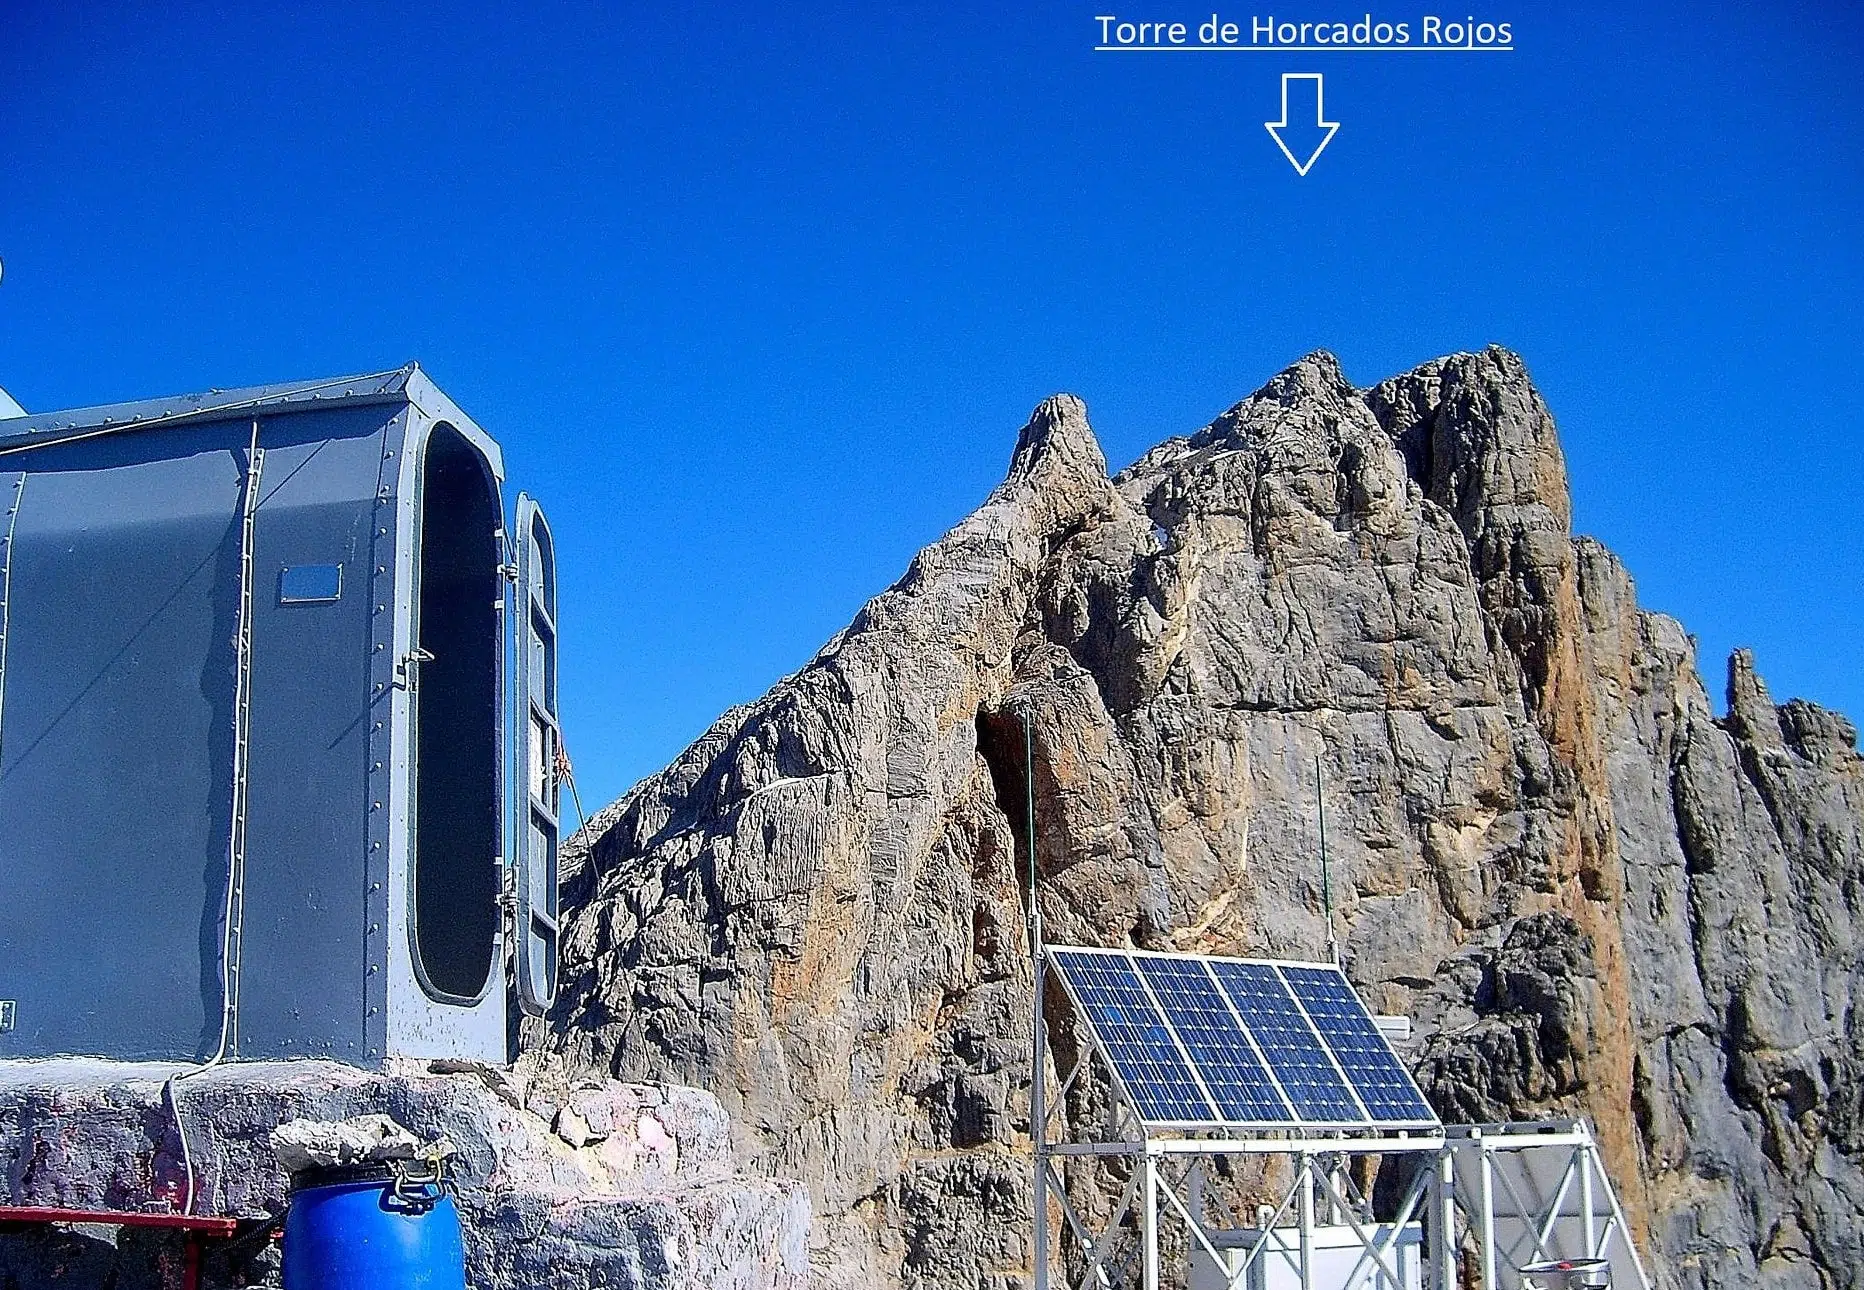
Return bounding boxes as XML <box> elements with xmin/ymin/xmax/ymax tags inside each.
<box><xmin>511</xmin><ymin>492</ymin><xmax>563</xmax><ymax>1016</ymax></box>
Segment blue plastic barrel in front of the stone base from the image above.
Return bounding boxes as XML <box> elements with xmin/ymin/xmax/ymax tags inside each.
<box><xmin>285</xmin><ymin>1169</ymin><xmax>466</xmax><ymax>1290</ymax></box>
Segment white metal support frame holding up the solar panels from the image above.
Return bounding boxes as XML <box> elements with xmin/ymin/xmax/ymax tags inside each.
<box><xmin>1031</xmin><ymin>943</ymin><xmax>1652</xmax><ymax>1290</ymax></box>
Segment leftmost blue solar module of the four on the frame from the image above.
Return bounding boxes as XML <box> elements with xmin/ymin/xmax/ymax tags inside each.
<box><xmin>1053</xmin><ymin>949</ymin><xmax>1213</xmax><ymax>1124</ymax></box>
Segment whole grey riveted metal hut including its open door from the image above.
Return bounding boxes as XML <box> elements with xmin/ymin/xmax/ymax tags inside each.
<box><xmin>0</xmin><ymin>365</ymin><xmax>559</xmax><ymax>1066</ymax></box>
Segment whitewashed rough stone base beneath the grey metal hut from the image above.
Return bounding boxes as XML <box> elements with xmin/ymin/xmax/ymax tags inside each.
<box><xmin>0</xmin><ymin>1061</ymin><xmax>809</xmax><ymax>1290</ymax></box>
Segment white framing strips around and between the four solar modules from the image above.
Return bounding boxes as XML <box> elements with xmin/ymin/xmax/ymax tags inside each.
<box><xmin>1048</xmin><ymin>945</ymin><xmax>1441</xmax><ymax>1133</ymax></box>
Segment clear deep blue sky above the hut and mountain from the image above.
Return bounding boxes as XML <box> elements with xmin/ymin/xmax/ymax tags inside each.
<box><xmin>0</xmin><ymin>0</ymin><xmax>1864</xmax><ymax>809</ymax></box>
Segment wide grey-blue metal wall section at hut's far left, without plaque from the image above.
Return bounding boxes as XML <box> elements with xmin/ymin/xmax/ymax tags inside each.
<box><xmin>0</xmin><ymin>425</ymin><xmax>248</xmax><ymax>1059</ymax></box>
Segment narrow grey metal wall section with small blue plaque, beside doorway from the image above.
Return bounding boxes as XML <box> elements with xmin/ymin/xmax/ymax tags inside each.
<box><xmin>239</xmin><ymin>406</ymin><xmax>391</xmax><ymax>1063</ymax></box>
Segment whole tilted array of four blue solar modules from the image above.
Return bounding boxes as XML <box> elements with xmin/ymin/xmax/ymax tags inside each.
<box><xmin>1049</xmin><ymin>949</ymin><xmax>1437</xmax><ymax>1128</ymax></box>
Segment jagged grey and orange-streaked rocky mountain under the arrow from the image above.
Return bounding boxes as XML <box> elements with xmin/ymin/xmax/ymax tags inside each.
<box><xmin>548</xmin><ymin>349</ymin><xmax>1864</xmax><ymax>1288</ymax></box>
